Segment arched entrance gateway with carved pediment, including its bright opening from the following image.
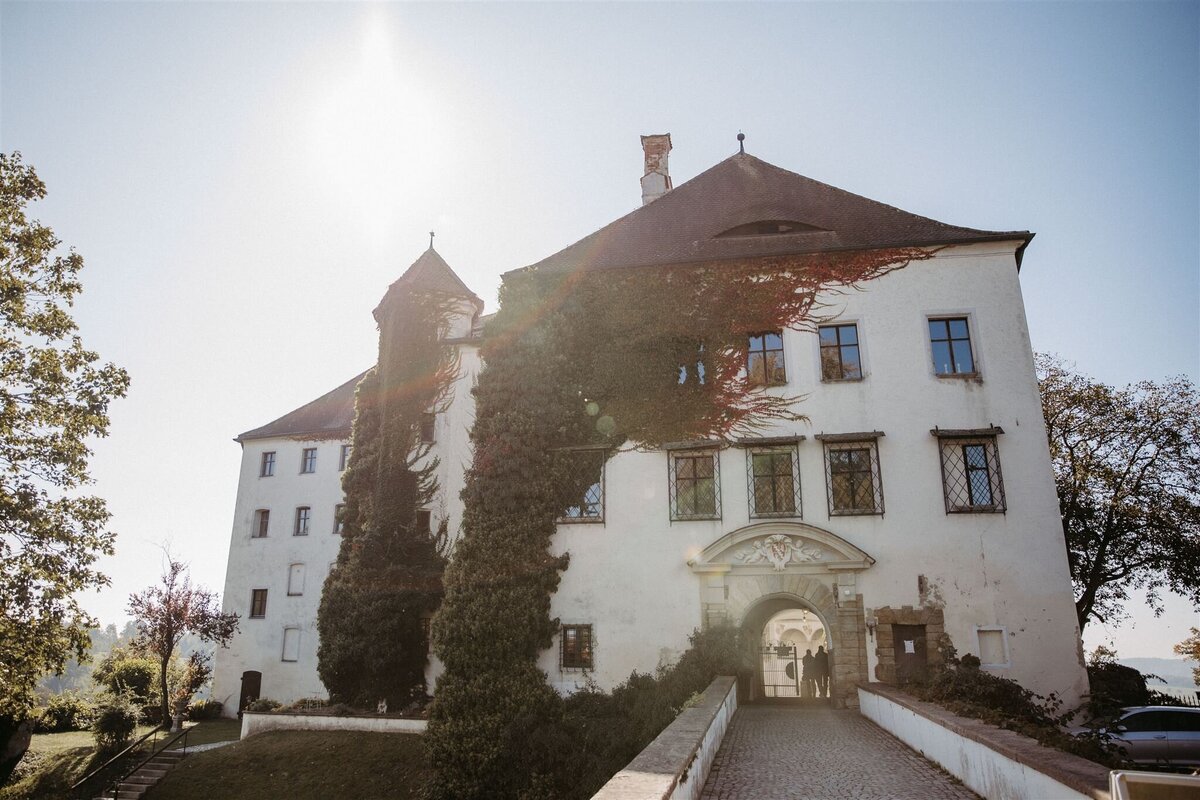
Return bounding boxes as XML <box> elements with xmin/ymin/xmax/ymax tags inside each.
<box><xmin>688</xmin><ymin>522</ymin><xmax>875</xmax><ymax>708</ymax></box>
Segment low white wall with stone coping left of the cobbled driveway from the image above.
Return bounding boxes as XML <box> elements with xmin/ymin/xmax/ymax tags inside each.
<box><xmin>592</xmin><ymin>678</ymin><xmax>738</xmax><ymax>800</ymax></box>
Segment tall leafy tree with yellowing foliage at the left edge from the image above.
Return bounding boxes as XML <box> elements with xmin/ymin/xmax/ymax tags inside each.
<box><xmin>0</xmin><ymin>152</ymin><xmax>130</xmax><ymax>780</ymax></box>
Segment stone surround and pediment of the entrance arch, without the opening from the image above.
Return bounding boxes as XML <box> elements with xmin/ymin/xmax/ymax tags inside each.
<box><xmin>688</xmin><ymin>522</ymin><xmax>875</xmax><ymax>708</ymax></box>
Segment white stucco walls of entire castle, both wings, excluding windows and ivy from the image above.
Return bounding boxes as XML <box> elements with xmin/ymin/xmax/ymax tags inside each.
<box><xmin>215</xmin><ymin>242</ymin><xmax>1086</xmax><ymax>703</ymax></box>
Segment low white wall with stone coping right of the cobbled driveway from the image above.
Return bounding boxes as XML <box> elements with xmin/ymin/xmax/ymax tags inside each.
<box><xmin>858</xmin><ymin>684</ymin><xmax>1110</xmax><ymax>800</ymax></box>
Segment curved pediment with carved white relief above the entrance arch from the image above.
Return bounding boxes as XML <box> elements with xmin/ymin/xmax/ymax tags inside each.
<box><xmin>688</xmin><ymin>522</ymin><xmax>875</xmax><ymax>572</ymax></box>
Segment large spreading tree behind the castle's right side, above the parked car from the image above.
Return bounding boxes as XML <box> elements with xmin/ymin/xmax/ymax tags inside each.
<box><xmin>1038</xmin><ymin>355</ymin><xmax>1200</xmax><ymax>628</ymax></box>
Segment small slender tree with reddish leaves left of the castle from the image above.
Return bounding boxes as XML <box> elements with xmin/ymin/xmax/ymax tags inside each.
<box><xmin>130</xmin><ymin>555</ymin><xmax>238</xmax><ymax>726</ymax></box>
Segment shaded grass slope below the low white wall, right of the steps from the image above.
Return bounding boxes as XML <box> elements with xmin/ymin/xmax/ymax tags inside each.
<box><xmin>145</xmin><ymin>730</ymin><xmax>428</xmax><ymax>800</ymax></box>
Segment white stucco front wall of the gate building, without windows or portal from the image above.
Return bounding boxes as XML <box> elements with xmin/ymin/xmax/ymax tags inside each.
<box><xmin>540</xmin><ymin>245</ymin><xmax>1086</xmax><ymax>702</ymax></box>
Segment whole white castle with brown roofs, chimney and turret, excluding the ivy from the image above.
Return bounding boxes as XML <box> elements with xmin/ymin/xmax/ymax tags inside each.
<box><xmin>214</xmin><ymin>136</ymin><xmax>1087</xmax><ymax>714</ymax></box>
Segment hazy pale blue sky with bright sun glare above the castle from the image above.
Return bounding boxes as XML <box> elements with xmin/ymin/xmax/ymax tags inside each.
<box><xmin>0</xmin><ymin>1</ymin><xmax>1200</xmax><ymax>656</ymax></box>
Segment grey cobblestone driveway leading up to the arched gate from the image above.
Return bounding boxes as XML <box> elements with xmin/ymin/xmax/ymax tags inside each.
<box><xmin>701</xmin><ymin>705</ymin><xmax>977</xmax><ymax>800</ymax></box>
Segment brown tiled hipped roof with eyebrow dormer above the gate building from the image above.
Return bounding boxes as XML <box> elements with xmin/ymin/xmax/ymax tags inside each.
<box><xmin>511</xmin><ymin>154</ymin><xmax>1033</xmax><ymax>278</ymax></box>
